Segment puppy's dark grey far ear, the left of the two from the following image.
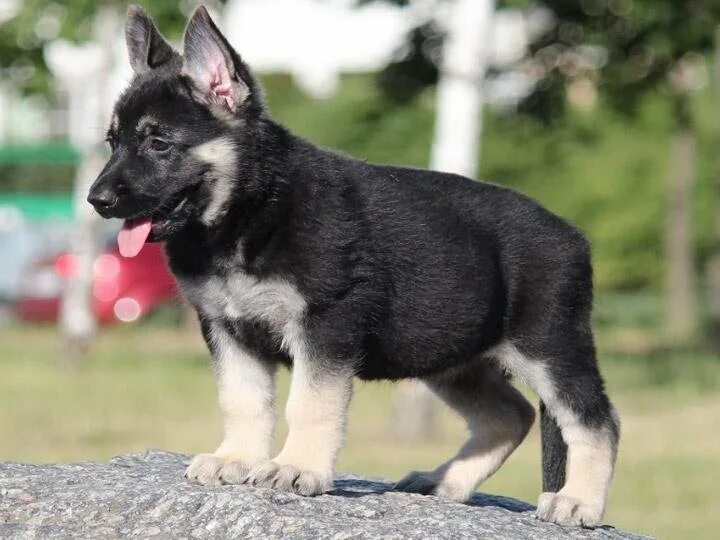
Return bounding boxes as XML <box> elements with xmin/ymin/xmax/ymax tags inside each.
<box><xmin>125</xmin><ymin>5</ymin><xmax>177</xmax><ymax>73</ymax></box>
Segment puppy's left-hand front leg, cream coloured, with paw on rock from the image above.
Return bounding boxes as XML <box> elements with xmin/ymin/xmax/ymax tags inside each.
<box><xmin>185</xmin><ymin>323</ymin><xmax>275</xmax><ymax>485</ymax></box>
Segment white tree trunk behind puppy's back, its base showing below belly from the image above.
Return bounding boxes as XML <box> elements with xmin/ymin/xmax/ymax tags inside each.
<box><xmin>394</xmin><ymin>0</ymin><xmax>495</xmax><ymax>440</ymax></box>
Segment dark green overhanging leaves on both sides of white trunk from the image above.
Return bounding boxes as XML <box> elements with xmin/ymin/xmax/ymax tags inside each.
<box><xmin>372</xmin><ymin>0</ymin><xmax>720</xmax><ymax>117</ymax></box>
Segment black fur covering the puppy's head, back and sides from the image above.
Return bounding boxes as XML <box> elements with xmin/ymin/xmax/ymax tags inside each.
<box><xmin>89</xmin><ymin>5</ymin><xmax>617</xmax><ymax>521</ymax></box>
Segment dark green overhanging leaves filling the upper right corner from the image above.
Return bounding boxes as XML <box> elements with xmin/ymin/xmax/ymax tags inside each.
<box><xmin>530</xmin><ymin>0</ymin><xmax>720</xmax><ymax>120</ymax></box>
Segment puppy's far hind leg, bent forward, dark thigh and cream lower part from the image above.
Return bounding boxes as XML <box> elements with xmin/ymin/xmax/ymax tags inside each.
<box><xmin>396</xmin><ymin>361</ymin><xmax>535</xmax><ymax>502</ymax></box>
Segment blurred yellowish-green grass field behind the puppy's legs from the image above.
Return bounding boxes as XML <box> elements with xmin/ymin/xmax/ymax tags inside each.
<box><xmin>0</xmin><ymin>310</ymin><xmax>720</xmax><ymax>539</ymax></box>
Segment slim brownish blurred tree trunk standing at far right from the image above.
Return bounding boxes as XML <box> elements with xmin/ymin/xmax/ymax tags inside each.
<box><xmin>665</xmin><ymin>94</ymin><xmax>698</xmax><ymax>345</ymax></box>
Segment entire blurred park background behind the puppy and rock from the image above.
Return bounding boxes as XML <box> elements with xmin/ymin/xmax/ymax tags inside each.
<box><xmin>0</xmin><ymin>0</ymin><xmax>720</xmax><ymax>538</ymax></box>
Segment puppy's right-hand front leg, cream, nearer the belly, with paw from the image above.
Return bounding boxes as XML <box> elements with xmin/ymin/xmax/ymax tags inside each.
<box><xmin>250</xmin><ymin>356</ymin><xmax>353</xmax><ymax>496</ymax></box>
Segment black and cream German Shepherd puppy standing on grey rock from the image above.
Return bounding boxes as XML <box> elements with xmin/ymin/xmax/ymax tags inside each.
<box><xmin>88</xmin><ymin>6</ymin><xmax>619</xmax><ymax>526</ymax></box>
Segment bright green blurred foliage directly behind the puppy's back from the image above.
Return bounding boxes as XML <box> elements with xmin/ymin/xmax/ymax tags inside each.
<box><xmin>264</xmin><ymin>76</ymin><xmax>715</xmax><ymax>290</ymax></box>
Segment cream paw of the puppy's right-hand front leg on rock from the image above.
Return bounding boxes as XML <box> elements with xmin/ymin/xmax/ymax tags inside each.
<box><xmin>247</xmin><ymin>461</ymin><xmax>332</xmax><ymax>497</ymax></box>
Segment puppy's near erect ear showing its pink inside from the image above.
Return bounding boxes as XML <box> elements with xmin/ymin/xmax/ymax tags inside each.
<box><xmin>182</xmin><ymin>6</ymin><xmax>250</xmax><ymax>112</ymax></box>
